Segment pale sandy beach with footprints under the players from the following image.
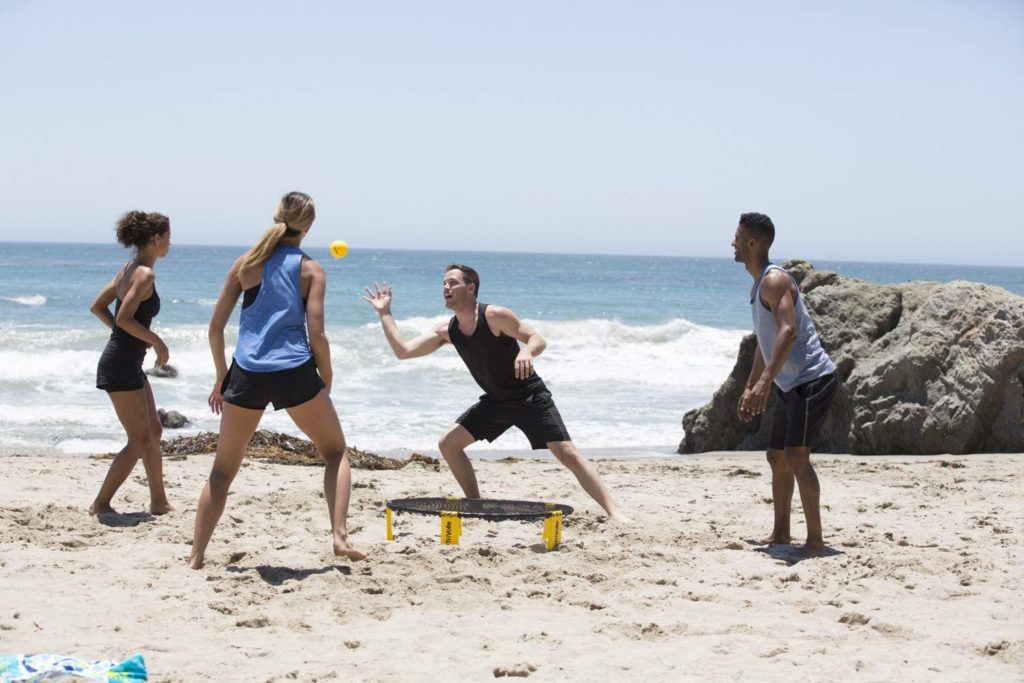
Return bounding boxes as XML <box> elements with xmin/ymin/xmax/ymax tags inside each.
<box><xmin>0</xmin><ymin>453</ymin><xmax>1024</xmax><ymax>681</ymax></box>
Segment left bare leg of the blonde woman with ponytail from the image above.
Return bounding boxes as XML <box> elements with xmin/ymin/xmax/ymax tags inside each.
<box><xmin>188</xmin><ymin>403</ymin><xmax>263</xmax><ymax>569</ymax></box>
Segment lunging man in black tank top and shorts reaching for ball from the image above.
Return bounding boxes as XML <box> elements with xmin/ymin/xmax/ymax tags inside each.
<box><xmin>364</xmin><ymin>263</ymin><xmax>629</xmax><ymax>522</ymax></box>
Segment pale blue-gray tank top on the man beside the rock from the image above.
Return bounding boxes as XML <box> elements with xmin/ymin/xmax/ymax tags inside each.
<box><xmin>751</xmin><ymin>263</ymin><xmax>836</xmax><ymax>391</ymax></box>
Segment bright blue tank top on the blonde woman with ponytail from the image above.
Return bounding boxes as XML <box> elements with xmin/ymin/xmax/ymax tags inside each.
<box><xmin>234</xmin><ymin>246</ymin><xmax>312</xmax><ymax>373</ymax></box>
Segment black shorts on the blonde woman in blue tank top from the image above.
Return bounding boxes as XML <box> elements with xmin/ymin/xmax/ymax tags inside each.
<box><xmin>220</xmin><ymin>358</ymin><xmax>327</xmax><ymax>411</ymax></box>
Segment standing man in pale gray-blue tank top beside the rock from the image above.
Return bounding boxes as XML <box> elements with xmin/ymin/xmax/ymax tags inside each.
<box><xmin>732</xmin><ymin>213</ymin><xmax>839</xmax><ymax>555</ymax></box>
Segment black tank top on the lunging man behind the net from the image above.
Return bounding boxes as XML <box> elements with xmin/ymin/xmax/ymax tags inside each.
<box><xmin>449</xmin><ymin>303</ymin><xmax>547</xmax><ymax>400</ymax></box>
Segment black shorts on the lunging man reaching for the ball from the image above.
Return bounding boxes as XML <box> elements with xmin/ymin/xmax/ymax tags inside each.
<box><xmin>456</xmin><ymin>391</ymin><xmax>572</xmax><ymax>451</ymax></box>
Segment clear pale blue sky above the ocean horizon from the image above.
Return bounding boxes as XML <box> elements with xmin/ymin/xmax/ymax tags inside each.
<box><xmin>0</xmin><ymin>0</ymin><xmax>1024</xmax><ymax>265</ymax></box>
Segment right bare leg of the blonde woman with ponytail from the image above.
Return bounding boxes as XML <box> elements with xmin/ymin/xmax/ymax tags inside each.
<box><xmin>288</xmin><ymin>389</ymin><xmax>367</xmax><ymax>561</ymax></box>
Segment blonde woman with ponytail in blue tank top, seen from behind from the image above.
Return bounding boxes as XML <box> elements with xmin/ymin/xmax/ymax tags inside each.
<box><xmin>188</xmin><ymin>193</ymin><xmax>366</xmax><ymax>569</ymax></box>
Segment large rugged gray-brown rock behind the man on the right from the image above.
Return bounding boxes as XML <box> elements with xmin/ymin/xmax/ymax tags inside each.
<box><xmin>679</xmin><ymin>261</ymin><xmax>1024</xmax><ymax>455</ymax></box>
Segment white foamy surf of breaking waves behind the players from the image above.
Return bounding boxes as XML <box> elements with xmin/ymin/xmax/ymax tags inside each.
<box><xmin>0</xmin><ymin>316</ymin><xmax>743</xmax><ymax>453</ymax></box>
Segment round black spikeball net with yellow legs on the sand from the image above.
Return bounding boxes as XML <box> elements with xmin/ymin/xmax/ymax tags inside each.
<box><xmin>384</xmin><ymin>498</ymin><xmax>572</xmax><ymax>550</ymax></box>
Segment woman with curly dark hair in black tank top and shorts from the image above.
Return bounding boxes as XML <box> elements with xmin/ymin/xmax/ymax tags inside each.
<box><xmin>89</xmin><ymin>211</ymin><xmax>174</xmax><ymax>515</ymax></box>
